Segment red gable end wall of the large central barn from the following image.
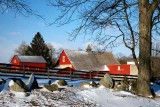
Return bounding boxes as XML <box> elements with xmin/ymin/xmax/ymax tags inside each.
<box><xmin>59</xmin><ymin>50</ymin><xmax>75</xmax><ymax>70</ymax></box>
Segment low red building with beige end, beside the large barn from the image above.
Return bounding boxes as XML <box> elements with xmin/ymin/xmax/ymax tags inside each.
<box><xmin>107</xmin><ymin>64</ymin><xmax>138</xmax><ymax>75</ymax></box>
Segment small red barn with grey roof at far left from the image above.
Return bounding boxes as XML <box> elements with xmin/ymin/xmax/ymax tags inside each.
<box><xmin>10</xmin><ymin>55</ymin><xmax>47</xmax><ymax>71</ymax></box>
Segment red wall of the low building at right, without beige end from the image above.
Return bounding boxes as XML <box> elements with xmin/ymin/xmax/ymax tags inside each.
<box><xmin>107</xmin><ymin>64</ymin><xmax>130</xmax><ymax>75</ymax></box>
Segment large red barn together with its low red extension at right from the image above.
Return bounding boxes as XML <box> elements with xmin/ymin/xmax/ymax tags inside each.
<box><xmin>57</xmin><ymin>44</ymin><xmax>138</xmax><ymax>75</ymax></box>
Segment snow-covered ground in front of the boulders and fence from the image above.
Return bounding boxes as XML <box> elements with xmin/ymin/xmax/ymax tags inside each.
<box><xmin>0</xmin><ymin>77</ymin><xmax>160</xmax><ymax>107</ymax></box>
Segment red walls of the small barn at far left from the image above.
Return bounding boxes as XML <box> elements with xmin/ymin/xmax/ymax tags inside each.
<box><xmin>11</xmin><ymin>56</ymin><xmax>46</xmax><ymax>71</ymax></box>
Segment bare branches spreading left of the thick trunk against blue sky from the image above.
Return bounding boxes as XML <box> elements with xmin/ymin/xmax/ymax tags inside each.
<box><xmin>50</xmin><ymin>0</ymin><xmax>138</xmax><ymax>67</ymax></box>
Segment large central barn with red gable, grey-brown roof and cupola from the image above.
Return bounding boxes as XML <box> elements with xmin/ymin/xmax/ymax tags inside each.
<box><xmin>57</xmin><ymin>46</ymin><xmax>119</xmax><ymax>71</ymax></box>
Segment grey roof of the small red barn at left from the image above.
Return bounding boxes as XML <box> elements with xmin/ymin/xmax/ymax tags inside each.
<box><xmin>16</xmin><ymin>55</ymin><xmax>46</xmax><ymax>63</ymax></box>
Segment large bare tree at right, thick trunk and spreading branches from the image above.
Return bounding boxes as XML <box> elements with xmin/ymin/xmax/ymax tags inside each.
<box><xmin>49</xmin><ymin>0</ymin><xmax>160</xmax><ymax>96</ymax></box>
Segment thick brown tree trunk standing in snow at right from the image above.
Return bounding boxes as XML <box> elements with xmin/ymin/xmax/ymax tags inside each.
<box><xmin>137</xmin><ymin>0</ymin><xmax>153</xmax><ymax>97</ymax></box>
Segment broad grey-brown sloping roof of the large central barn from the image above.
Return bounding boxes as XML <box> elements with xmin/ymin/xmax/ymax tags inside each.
<box><xmin>64</xmin><ymin>50</ymin><xmax>119</xmax><ymax>71</ymax></box>
